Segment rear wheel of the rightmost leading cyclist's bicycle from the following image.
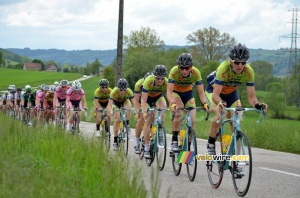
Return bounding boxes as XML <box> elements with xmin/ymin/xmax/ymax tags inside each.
<box><xmin>206</xmin><ymin>133</ymin><xmax>224</xmax><ymax>188</ymax></box>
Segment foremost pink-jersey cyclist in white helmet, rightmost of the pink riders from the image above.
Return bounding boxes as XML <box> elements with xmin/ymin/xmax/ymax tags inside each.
<box><xmin>66</xmin><ymin>80</ymin><xmax>87</xmax><ymax>130</ymax></box>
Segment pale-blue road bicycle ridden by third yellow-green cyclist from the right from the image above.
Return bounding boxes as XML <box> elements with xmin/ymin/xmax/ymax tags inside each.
<box><xmin>139</xmin><ymin>108</ymin><xmax>167</xmax><ymax>171</ymax></box>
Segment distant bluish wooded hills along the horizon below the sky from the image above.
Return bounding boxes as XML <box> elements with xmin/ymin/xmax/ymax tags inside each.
<box><xmin>6</xmin><ymin>46</ymin><xmax>289</xmax><ymax>76</ymax></box>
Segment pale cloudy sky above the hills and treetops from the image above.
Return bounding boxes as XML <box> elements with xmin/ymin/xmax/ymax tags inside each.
<box><xmin>0</xmin><ymin>0</ymin><xmax>300</xmax><ymax>50</ymax></box>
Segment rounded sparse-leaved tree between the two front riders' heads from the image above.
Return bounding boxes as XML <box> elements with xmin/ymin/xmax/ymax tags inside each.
<box><xmin>186</xmin><ymin>27</ymin><xmax>236</xmax><ymax>65</ymax></box>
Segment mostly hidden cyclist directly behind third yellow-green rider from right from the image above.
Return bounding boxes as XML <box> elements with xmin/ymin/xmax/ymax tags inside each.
<box><xmin>134</xmin><ymin>72</ymin><xmax>153</xmax><ymax>154</ymax></box>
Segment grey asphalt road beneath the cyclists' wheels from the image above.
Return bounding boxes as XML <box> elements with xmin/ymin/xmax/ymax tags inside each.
<box><xmin>81</xmin><ymin>122</ymin><xmax>300</xmax><ymax>198</ymax></box>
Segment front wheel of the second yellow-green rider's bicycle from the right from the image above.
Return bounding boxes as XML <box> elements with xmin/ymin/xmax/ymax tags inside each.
<box><xmin>186</xmin><ymin>128</ymin><xmax>197</xmax><ymax>181</ymax></box>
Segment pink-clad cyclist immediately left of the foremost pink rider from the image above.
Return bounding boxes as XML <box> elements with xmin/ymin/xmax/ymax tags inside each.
<box><xmin>53</xmin><ymin>80</ymin><xmax>71</xmax><ymax>126</ymax></box>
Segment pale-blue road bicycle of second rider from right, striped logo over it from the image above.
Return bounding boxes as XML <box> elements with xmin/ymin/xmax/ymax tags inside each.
<box><xmin>170</xmin><ymin>107</ymin><xmax>209</xmax><ymax>181</ymax></box>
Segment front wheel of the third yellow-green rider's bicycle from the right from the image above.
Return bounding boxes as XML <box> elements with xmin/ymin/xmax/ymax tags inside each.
<box><xmin>155</xmin><ymin>127</ymin><xmax>167</xmax><ymax>171</ymax></box>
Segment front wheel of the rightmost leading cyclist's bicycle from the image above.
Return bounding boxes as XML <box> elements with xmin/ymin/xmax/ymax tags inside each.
<box><xmin>231</xmin><ymin>132</ymin><xmax>252</xmax><ymax>197</ymax></box>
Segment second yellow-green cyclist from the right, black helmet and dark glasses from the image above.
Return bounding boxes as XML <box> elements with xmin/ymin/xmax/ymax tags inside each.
<box><xmin>167</xmin><ymin>53</ymin><xmax>209</xmax><ymax>152</ymax></box>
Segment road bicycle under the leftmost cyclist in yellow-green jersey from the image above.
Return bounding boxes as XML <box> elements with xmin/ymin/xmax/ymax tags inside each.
<box><xmin>96</xmin><ymin>109</ymin><xmax>110</xmax><ymax>150</ymax></box>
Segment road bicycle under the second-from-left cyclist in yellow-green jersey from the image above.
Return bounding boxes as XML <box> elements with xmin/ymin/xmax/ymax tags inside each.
<box><xmin>113</xmin><ymin>107</ymin><xmax>131</xmax><ymax>156</ymax></box>
